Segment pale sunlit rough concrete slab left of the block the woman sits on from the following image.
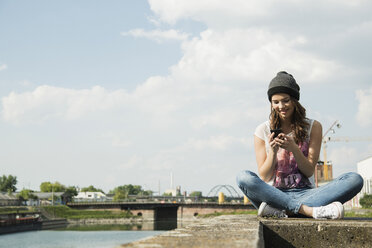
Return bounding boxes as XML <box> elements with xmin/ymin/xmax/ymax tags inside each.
<box><xmin>122</xmin><ymin>215</ymin><xmax>264</xmax><ymax>248</ymax></box>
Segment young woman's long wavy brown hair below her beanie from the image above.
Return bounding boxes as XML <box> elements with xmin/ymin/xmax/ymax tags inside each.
<box><xmin>270</xmin><ymin>97</ymin><xmax>309</xmax><ymax>144</ymax></box>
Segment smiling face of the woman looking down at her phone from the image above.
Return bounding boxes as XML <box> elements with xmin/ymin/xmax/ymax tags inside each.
<box><xmin>271</xmin><ymin>93</ymin><xmax>295</xmax><ymax>120</ymax></box>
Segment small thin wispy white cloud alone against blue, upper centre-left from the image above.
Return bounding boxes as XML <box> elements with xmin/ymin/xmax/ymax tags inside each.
<box><xmin>121</xmin><ymin>29</ymin><xmax>189</xmax><ymax>43</ymax></box>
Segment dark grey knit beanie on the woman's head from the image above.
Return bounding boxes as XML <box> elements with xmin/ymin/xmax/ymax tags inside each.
<box><xmin>267</xmin><ymin>71</ymin><xmax>300</xmax><ymax>102</ymax></box>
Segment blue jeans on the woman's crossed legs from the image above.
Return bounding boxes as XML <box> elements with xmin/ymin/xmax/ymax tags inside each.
<box><xmin>236</xmin><ymin>171</ymin><xmax>363</xmax><ymax>214</ymax></box>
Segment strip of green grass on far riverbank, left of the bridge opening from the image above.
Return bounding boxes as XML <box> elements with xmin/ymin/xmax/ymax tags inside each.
<box><xmin>42</xmin><ymin>206</ymin><xmax>136</xmax><ymax>219</ymax></box>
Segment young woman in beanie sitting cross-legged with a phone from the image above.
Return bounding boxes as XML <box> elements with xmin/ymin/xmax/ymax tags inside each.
<box><xmin>237</xmin><ymin>71</ymin><xmax>363</xmax><ymax>219</ymax></box>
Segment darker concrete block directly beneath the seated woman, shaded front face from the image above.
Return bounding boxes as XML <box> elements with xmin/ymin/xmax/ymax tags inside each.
<box><xmin>259</xmin><ymin>218</ymin><xmax>372</xmax><ymax>248</ymax></box>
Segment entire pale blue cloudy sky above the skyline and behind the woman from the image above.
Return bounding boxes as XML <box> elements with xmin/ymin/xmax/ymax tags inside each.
<box><xmin>0</xmin><ymin>0</ymin><xmax>372</xmax><ymax>194</ymax></box>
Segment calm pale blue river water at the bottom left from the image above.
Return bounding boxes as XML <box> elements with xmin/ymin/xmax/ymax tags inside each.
<box><xmin>0</xmin><ymin>229</ymin><xmax>164</xmax><ymax>248</ymax></box>
